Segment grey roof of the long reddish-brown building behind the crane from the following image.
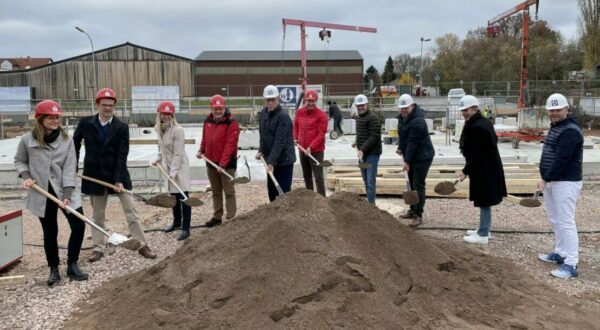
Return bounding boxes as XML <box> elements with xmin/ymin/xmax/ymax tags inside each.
<box><xmin>196</xmin><ymin>50</ymin><xmax>363</xmax><ymax>61</ymax></box>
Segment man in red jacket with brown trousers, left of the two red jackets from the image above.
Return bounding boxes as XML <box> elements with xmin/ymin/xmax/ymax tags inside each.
<box><xmin>196</xmin><ymin>94</ymin><xmax>240</xmax><ymax>227</ymax></box>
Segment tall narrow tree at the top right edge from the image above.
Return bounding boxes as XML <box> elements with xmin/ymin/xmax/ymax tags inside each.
<box><xmin>579</xmin><ymin>0</ymin><xmax>600</xmax><ymax>71</ymax></box>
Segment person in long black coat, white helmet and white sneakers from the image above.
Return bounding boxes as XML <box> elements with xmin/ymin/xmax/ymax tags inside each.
<box><xmin>459</xmin><ymin>95</ymin><xmax>506</xmax><ymax>244</ymax></box>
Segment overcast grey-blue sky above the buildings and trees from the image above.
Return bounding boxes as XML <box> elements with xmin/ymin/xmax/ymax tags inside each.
<box><xmin>0</xmin><ymin>0</ymin><xmax>579</xmax><ymax>71</ymax></box>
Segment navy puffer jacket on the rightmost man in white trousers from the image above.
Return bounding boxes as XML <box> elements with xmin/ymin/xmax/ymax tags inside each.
<box><xmin>540</xmin><ymin>117</ymin><xmax>583</xmax><ymax>182</ymax></box>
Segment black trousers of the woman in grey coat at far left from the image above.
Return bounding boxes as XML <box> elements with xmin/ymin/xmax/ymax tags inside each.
<box><xmin>39</xmin><ymin>184</ymin><xmax>85</xmax><ymax>267</ymax></box>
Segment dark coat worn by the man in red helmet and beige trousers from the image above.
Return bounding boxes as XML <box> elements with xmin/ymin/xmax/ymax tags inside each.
<box><xmin>73</xmin><ymin>115</ymin><xmax>131</xmax><ymax>196</ymax></box>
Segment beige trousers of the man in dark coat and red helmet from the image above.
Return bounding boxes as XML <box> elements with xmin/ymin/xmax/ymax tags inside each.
<box><xmin>90</xmin><ymin>192</ymin><xmax>146</xmax><ymax>252</ymax></box>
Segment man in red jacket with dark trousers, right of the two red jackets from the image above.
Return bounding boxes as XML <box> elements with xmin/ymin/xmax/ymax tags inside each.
<box><xmin>294</xmin><ymin>90</ymin><xmax>327</xmax><ymax>196</ymax></box>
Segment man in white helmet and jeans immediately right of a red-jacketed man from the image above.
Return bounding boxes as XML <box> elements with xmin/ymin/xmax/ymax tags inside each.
<box><xmin>352</xmin><ymin>94</ymin><xmax>382</xmax><ymax>204</ymax></box>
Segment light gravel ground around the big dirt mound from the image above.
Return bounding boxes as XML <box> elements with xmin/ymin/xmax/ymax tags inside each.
<box><xmin>0</xmin><ymin>182</ymin><xmax>600</xmax><ymax>329</ymax></box>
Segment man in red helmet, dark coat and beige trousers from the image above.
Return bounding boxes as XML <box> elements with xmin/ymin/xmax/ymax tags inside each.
<box><xmin>73</xmin><ymin>88</ymin><xmax>156</xmax><ymax>262</ymax></box>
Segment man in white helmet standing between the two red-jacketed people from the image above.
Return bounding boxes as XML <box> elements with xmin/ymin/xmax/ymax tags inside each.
<box><xmin>256</xmin><ymin>85</ymin><xmax>296</xmax><ymax>202</ymax></box>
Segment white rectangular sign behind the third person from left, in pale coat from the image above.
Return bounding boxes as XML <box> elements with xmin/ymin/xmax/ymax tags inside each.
<box><xmin>131</xmin><ymin>86</ymin><xmax>179</xmax><ymax>113</ymax></box>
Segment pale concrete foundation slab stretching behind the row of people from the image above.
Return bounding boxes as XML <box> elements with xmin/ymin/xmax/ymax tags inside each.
<box><xmin>0</xmin><ymin>125</ymin><xmax>600</xmax><ymax>190</ymax></box>
